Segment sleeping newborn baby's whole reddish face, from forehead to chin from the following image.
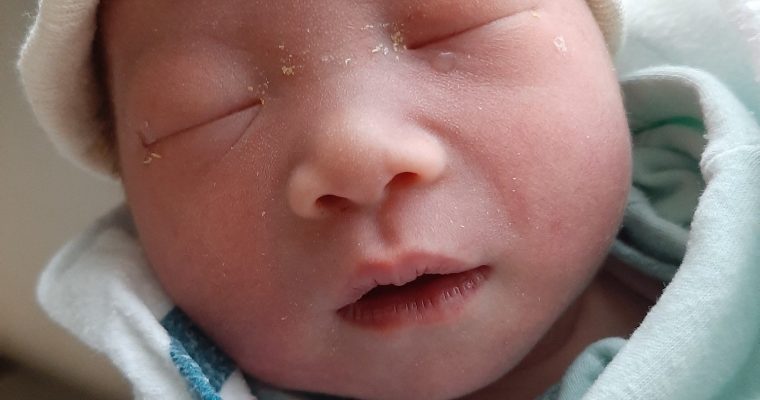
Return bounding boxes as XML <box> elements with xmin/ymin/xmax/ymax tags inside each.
<box><xmin>101</xmin><ymin>0</ymin><xmax>630</xmax><ymax>399</ymax></box>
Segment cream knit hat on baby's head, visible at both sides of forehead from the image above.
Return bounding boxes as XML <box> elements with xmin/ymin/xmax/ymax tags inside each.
<box><xmin>18</xmin><ymin>0</ymin><xmax>623</xmax><ymax>178</ymax></box>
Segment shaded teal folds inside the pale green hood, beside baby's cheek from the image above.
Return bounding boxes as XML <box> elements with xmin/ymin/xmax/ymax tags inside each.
<box><xmin>612</xmin><ymin>117</ymin><xmax>705</xmax><ymax>281</ymax></box>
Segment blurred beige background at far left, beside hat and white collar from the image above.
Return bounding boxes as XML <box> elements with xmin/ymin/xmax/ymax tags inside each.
<box><xmin>0</xmin><ymin>0</ymin><xmax>131</xmax><ymax>400</ymax></box>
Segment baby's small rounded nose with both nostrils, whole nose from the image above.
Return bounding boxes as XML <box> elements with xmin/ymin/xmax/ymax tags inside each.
<box><xmin>288</xmin><ymin>112</ymin><xmax>447</xmax><ymax>218</ymax></box>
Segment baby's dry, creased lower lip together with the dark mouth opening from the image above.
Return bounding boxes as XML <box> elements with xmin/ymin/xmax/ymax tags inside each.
<box><xmin>338</xmin><ymin>265</ymin><xmax>490</xmax><ymax>330</ymax></box>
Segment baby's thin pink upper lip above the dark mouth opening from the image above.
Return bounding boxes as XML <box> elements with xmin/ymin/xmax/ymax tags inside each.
<box><xmin>341</xmin><ymin>252</ymin><xmax>477</xmax><ymax>307</ymax></box>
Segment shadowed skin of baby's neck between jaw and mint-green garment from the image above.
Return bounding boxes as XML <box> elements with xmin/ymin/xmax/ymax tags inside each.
<box><xmin>461</xmin><ymin>258</ymin><xmax>662</xmax><ymax>400</ymax></box>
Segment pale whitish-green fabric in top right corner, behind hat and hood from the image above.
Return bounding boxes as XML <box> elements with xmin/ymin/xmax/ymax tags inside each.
<box><xmin>616</xmin><ymin>0</ymin><xmax>760</xmax><ymax>120</ymax></box>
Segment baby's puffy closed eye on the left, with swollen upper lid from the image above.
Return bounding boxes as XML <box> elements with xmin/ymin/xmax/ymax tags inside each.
<box><xmin>127</xmin><ymin>41</ymin><xmax>262</xmax><ymax>146</ymax></box>
